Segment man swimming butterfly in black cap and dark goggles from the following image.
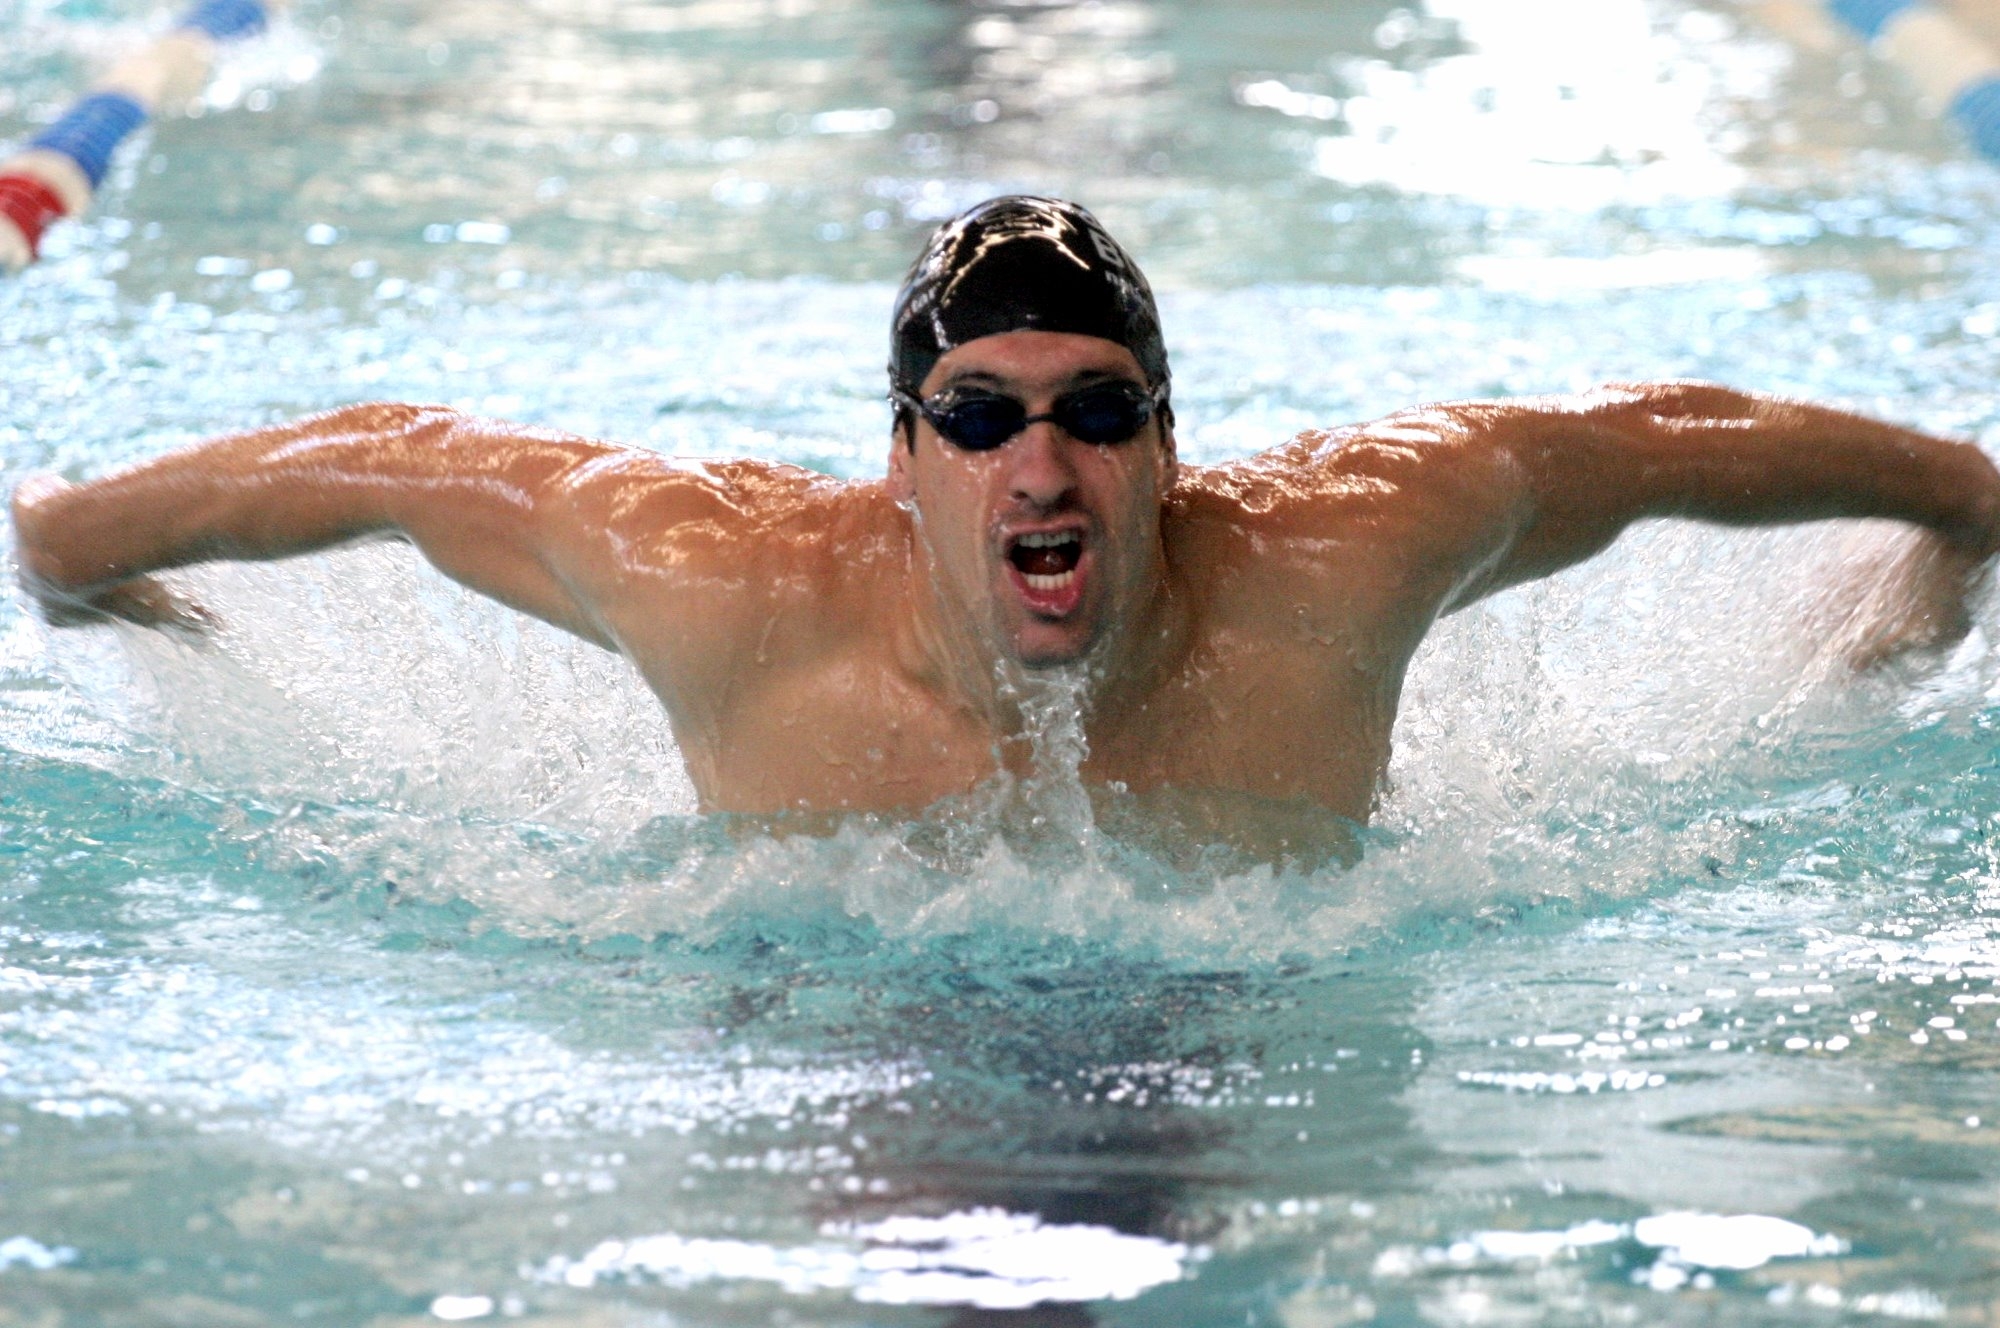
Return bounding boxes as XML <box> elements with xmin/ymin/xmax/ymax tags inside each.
<box><xmin>14</xmin><ymin>198</ymin><xmax>2000</xmax><ymax>820</ymax></box>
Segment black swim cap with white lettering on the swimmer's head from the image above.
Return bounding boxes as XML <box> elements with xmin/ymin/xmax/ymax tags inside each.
<box><xmin>888</xmin><ymin>194</ymin><xmax>1168</xmax><ymax>394</ymax></box>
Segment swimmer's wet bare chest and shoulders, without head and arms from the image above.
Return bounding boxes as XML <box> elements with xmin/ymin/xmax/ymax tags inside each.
<box><xmin>584</xmin><ymin>436</ymin><xmax>1464</xmax><ymax>820</ymax></box>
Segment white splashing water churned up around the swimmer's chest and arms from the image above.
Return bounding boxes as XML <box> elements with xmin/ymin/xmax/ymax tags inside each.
<box><xmin>24</xmin><ymin>492</ymin><xmax>1996</xmax><ymax>972</ymax></box>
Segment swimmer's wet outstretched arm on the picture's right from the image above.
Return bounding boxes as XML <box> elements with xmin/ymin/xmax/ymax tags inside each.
<box><xmin>1432</xmin><ymin>382</ymin><xmax>2000</xmax><ymax>610</ymax></box>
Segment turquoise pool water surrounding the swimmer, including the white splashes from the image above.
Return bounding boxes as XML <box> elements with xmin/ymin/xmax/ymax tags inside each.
<box><xmin>11</xmin><ymin>0</ymin><xmax>2000</xmax><ymax>1328</ymax></box>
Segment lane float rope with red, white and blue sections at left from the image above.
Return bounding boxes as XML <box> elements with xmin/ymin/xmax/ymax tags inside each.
<box><xmin>0</xmin><ymin>0</ymin><xmax>270</xmax><ymax>272</ymax></box>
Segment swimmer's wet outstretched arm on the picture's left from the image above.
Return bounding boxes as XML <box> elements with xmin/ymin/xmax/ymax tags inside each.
<box><xmin>14</xmin><ymin>404</ymin><xmax>622</xmax><ymax>646</ymax></box>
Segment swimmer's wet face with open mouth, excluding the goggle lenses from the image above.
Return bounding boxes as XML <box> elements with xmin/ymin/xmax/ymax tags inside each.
<box><xmin>890</xmin><ymin>332</ymin><xmax>1174</xmax><ymax>666</ymax></box>
